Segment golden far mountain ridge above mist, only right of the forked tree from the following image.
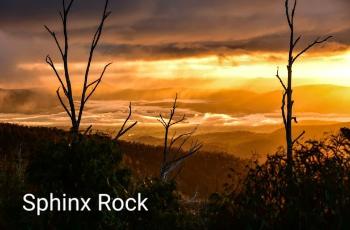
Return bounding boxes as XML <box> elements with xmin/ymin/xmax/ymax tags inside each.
<box><xmin>98</xmin><ymin>85</ymin><xmax>350</xmax><ymax>114</ymax></box>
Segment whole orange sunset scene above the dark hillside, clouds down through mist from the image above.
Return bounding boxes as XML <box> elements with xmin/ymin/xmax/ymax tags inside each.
<box><xmin>0</xmin><ymin>0</ymin><xmax>350</xmax><ymax>137</ymax></box>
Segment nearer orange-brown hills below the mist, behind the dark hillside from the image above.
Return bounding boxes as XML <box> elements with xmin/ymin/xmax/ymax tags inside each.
<box><xmin>127</xmin><ymin>123</ymin><xmax>350</xmax><ymax>158</ymax></box>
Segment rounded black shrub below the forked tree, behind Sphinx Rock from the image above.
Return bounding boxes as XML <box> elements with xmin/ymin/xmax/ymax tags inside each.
<box><xmin>23</xmin><ymin>135</ymin><xmax>130</xmax><ymax>229</ymax></box>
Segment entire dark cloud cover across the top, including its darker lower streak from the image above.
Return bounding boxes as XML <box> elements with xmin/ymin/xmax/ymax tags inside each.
<box><xmin>0</xmin><ymin>0</ymin><xmax>350</xmax><ymax>83</ymax></box>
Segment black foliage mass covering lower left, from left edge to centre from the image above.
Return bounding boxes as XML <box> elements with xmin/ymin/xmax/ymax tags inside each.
<box><xmin>0</xmin><ymin>125</ymin><xmax>204</xmax><ymax>229</ymax></box>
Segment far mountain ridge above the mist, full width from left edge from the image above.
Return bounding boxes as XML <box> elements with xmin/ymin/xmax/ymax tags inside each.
<box><xmin>0</xmin><ymin>85</ymin><xmax>350</xmax><ymax>114</ymax></box>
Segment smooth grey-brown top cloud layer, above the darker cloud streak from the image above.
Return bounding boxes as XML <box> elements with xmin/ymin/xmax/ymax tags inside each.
<box><xmin>0</xmin><ymin>0</ymin><xmax>350</xmax><ymax>43</ymax></box>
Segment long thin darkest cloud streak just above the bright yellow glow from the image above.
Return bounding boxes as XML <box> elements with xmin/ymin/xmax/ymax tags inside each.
<box><xmin>100</xmin><ymin>29</ymin><xmax>350</xmax><ymax>60</ymax></box>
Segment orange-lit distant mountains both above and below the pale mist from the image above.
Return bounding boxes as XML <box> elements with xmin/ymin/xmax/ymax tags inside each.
<box><xmin>0</xmin><ymin>85</ymin><xmax>350</xmax><ymax>158</ymax></box>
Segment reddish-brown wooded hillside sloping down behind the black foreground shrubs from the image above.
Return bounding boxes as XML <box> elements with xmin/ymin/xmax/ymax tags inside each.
<box><xmin>0</xmin><ymin>124</ymin><xmax>248</xmax><ymax>198</ymax></box>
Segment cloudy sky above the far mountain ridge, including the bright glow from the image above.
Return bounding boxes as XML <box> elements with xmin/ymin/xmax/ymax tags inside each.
<box><xmin>0</xmin><ymin>0</ymin><xmax>350</xmax><ymax>92</ymax></box>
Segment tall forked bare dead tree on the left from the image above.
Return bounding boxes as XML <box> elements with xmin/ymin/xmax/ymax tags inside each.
<box><xmin>45</xmin><ymin>0</ymin><xmax>111</xmax><ymax>134</ymax></box>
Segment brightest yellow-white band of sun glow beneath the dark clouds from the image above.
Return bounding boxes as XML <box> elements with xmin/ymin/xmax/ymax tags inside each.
<box><xmin>18</xmin><ymin>50</ymin><xmax>350</xmax><ymax>90</ymax></box>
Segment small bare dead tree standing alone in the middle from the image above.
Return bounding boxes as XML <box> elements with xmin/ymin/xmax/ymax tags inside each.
<box><xmin>158</xmin><ymin>94</ymin><xmax>202</xmax><ymax>181</ymax></box>
